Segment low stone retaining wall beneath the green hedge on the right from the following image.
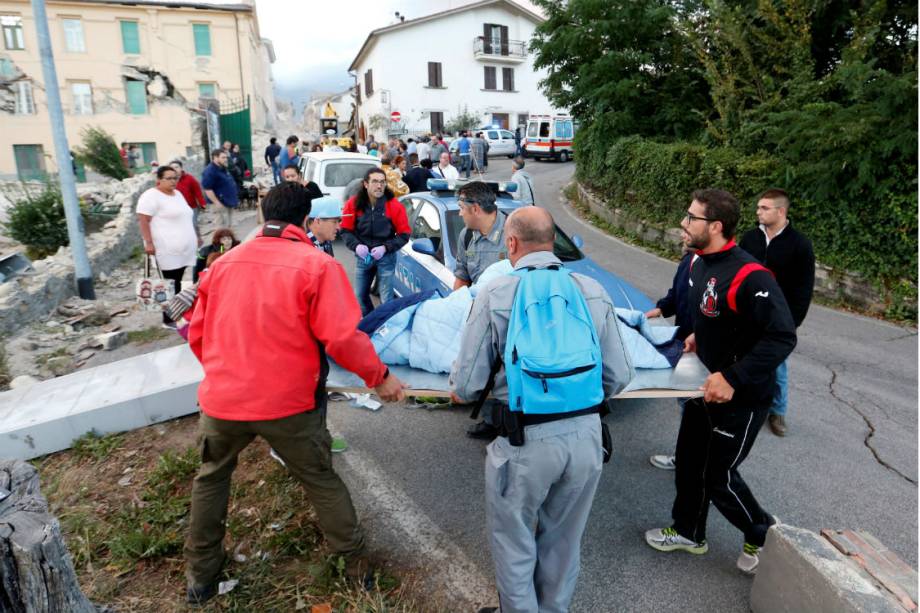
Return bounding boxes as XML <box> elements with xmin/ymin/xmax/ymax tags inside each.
<box><xmin>575</xmin><ymin>181</ymin><xmax>900</xmax><ymax>313</ymax></box>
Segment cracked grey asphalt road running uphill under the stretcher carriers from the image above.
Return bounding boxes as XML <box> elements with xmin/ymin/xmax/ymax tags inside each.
<box><xmin>314</xmin><ymin>160</ymin><xmax>918</xmax><ymax>612</ymax></box>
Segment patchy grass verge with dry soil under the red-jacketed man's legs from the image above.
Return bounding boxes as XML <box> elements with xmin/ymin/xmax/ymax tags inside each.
<box><xmin>40</xmin><ymin>417</ymin><xmax>446</xmax><ymax>613</ymax></box>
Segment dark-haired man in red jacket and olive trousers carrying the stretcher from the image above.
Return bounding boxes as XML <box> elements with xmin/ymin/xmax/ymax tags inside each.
<box><xmin>185</xmin><ymin>183</ymin><xmax>404</xmax><ymax>604</ymax></box>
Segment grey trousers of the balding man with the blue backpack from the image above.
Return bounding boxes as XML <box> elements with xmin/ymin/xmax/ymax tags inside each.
<box><xmin>485</xmin><ymin>415</ymin><xmax>603</xmax><ymax>613</ymax></box>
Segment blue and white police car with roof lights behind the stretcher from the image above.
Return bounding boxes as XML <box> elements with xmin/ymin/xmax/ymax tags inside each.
<box><xmin>393</xmin><ymin>179</ymin><xmax>655</xmax><ymax>311</ymax></box>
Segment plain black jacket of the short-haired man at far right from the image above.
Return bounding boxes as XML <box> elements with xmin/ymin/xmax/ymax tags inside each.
<box><xmin>738</xmin><ymin>222</ymin><xmax>815</xmax><ymax>328</ymax></box>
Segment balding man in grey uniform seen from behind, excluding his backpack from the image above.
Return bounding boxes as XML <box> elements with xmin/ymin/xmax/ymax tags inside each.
<box><xmin>450</xmin><ymin>207</ymin><xmax>634</xmax><ymax>613</ymax></box>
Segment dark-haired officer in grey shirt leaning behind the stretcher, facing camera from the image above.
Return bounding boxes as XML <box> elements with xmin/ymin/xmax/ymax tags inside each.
<box><xmin>454</xmin><ymin>181</ymin><xmax>508</xmax><ymax>440</ymax></box>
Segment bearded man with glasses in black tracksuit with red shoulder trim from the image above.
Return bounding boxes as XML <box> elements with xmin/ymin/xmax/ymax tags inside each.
<box><xmin>645</xmin><ymin>190</ymin><xmax>796</xmax><ymax>574</ymax></box>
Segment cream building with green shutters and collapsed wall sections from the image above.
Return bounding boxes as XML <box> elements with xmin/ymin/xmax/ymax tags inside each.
<box><xmin>0</xmin><ymin>0</ymin><xmax>275</xmax><ymax>179</ymax></box>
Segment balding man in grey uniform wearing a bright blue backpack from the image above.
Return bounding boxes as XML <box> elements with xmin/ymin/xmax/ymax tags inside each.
<box><xmin>450</xmin><ymin>207</ymin><xmax>634</xmax><ymax>613</ymax></box>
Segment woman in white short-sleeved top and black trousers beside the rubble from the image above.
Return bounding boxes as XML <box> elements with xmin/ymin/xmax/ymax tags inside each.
<box><xmin>137</xmin><ymin>166</ymin><xmax>198</xmax><ymax>327</ymax></box>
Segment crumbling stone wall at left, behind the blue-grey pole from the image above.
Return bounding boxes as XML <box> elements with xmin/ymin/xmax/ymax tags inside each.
<box><xmin>0</xmin><ymin>159</ymin><xmax>202</xmax><ymax>334</ymax></box>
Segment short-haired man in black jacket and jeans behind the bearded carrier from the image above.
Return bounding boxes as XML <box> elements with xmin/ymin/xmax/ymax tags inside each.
<box><xmin>738</xmin><ymin>188</ymin><xmax>815</xmax><ymax>436</ymax></box>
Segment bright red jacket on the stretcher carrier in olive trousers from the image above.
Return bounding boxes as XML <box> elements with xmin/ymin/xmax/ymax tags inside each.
<box><xmin>188</xmin><ymin>225</ymin><xmax>386</xmax><ymax>421</ymax></box>
